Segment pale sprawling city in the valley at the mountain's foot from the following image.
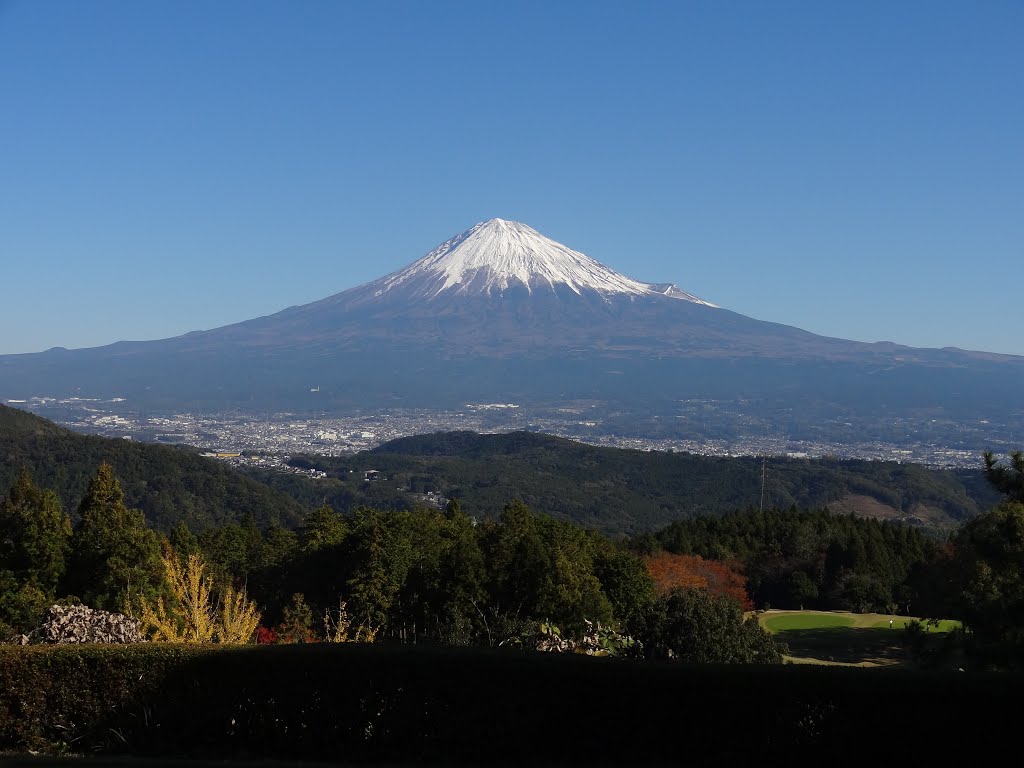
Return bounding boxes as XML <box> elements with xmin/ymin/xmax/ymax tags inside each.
<box><xmin>7</xmin><ymin>396</ymin><xmax>1016</xmax><ymax>475</ymax></box>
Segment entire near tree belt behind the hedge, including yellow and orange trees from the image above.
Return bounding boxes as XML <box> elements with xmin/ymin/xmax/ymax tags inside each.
<box><xmin>0</xmin><ymin>454</ymin><xmax>1024</xmax><ymax>666</ymax></box>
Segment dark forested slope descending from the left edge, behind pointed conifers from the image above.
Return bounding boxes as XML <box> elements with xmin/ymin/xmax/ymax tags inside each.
<box><xmin>0</xmin><ymin>406</ymin><xmax>303</xmax><ymax>530</ymax></box>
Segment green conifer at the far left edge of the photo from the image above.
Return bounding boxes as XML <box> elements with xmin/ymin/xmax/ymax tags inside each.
<box><xmin>0</xmin><ymin>468</ymin><xmax>72</xmax><ymax>599</ymax></box>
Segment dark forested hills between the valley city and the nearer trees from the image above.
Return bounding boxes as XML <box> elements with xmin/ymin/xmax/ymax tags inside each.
<box><xmin>0</xmin><ymin>406</ymin><xmax>998</xmax><ymax>537</ymax></box>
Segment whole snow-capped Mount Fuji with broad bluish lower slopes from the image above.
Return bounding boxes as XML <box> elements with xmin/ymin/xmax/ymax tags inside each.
<box><xmin>0</xmin><ymin>218</ymin><xmax>1024</xmax><ymax>430</ymax></box>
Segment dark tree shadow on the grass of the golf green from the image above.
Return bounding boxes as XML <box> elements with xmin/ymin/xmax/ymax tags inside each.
<box><xmin>775</xmin><ymin>627</ymin><xmax>909</xmax><ymax>665</ymax></box>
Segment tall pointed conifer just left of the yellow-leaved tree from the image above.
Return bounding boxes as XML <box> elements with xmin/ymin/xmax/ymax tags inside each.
<box><xmin>66</xmin><ymin>463</ymin><xmax>164</xmax><ymax>611</ymax></box>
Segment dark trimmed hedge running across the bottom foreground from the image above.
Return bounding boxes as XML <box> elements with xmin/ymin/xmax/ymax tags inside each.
<box><xmin>0</xmin><ymin>644</ymin><xmax>1022</xmax><ymax>764</ymax></box>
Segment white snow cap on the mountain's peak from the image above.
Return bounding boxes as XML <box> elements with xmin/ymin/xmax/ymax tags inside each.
<box><xmin>376</xmin><ymin>218</ymin><xmax>714</xmax><ymax>306</ymax></box>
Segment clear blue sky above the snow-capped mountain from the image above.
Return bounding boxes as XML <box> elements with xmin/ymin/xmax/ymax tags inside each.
<box><xmin>0</xmin><ymin>0</ymin><xmax>1024</xmax><ymax>354</ymax></box>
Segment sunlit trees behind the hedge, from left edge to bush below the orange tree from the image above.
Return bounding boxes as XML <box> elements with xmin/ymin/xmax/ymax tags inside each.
<box><xmin>0</xmin><ymin>464</ymin><xmax>780</xmax><ymax>662</ymax></box>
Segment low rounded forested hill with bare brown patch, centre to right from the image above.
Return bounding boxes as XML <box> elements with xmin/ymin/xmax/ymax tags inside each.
<box><xmin>276</xmin><ymin>432</ymin><xmax>997</xmax><ymax>535</ymax></box>
